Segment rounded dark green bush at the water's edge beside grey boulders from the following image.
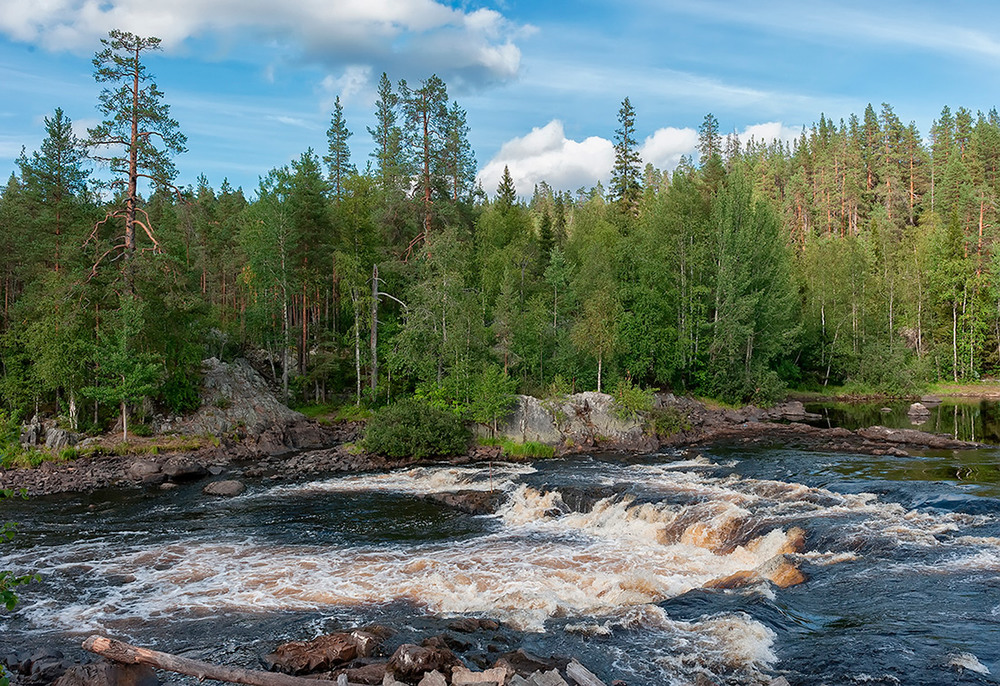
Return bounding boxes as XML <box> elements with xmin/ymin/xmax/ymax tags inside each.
<box><xmin>364</xmin><ymin>398</ymin><xmax>471</xmax><ymax>460</ymax></box>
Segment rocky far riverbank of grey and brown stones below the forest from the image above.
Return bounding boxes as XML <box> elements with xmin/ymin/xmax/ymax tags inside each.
<box><xmin>0</xmin><ymin>394</ymin><xmax>981</xmax><ymax>496</ymax></box>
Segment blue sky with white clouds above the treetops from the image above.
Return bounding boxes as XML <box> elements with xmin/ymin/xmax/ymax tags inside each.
<box><xmin>0</xmin><ymin>0</ymin><xmax>1000</xmax><ymax>196</ymax></box>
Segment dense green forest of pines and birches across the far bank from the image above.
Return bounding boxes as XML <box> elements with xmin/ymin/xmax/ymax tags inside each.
<box><xmin>0</xmin><ymin>31</ymin><xmax>1000</xmax><ymax>438</ymax></box>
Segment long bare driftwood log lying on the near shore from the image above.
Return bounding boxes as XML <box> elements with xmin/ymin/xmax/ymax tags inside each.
<box><xmin>83</xmin><ymin>636</ymin><xmax>364</xmax><ymax>686</ymax></box>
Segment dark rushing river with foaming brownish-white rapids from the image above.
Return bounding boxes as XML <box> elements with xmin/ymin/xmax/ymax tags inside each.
<box><xmin>0</xmin><ymin>448</ymin><xmax>1000</xmax><ymax>686</ymax></box>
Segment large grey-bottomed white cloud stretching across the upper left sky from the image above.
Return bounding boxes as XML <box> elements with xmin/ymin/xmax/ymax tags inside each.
<box><xmin>0</xmin><ymin>0</ymin><xmax>531</xmax><ymax>87</ymax></box>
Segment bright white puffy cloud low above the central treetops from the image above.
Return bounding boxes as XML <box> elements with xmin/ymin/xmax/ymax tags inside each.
<box><xmin>479</xmin><ymin>119</ymin><xmax>615</xmax><ymax>196</ymax></box>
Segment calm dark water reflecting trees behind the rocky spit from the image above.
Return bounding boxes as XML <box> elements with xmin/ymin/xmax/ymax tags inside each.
<box><xmin>805</xmin><ymin>398</ymin><xmax>1000</xmax><ymax>445</ymax></box>
